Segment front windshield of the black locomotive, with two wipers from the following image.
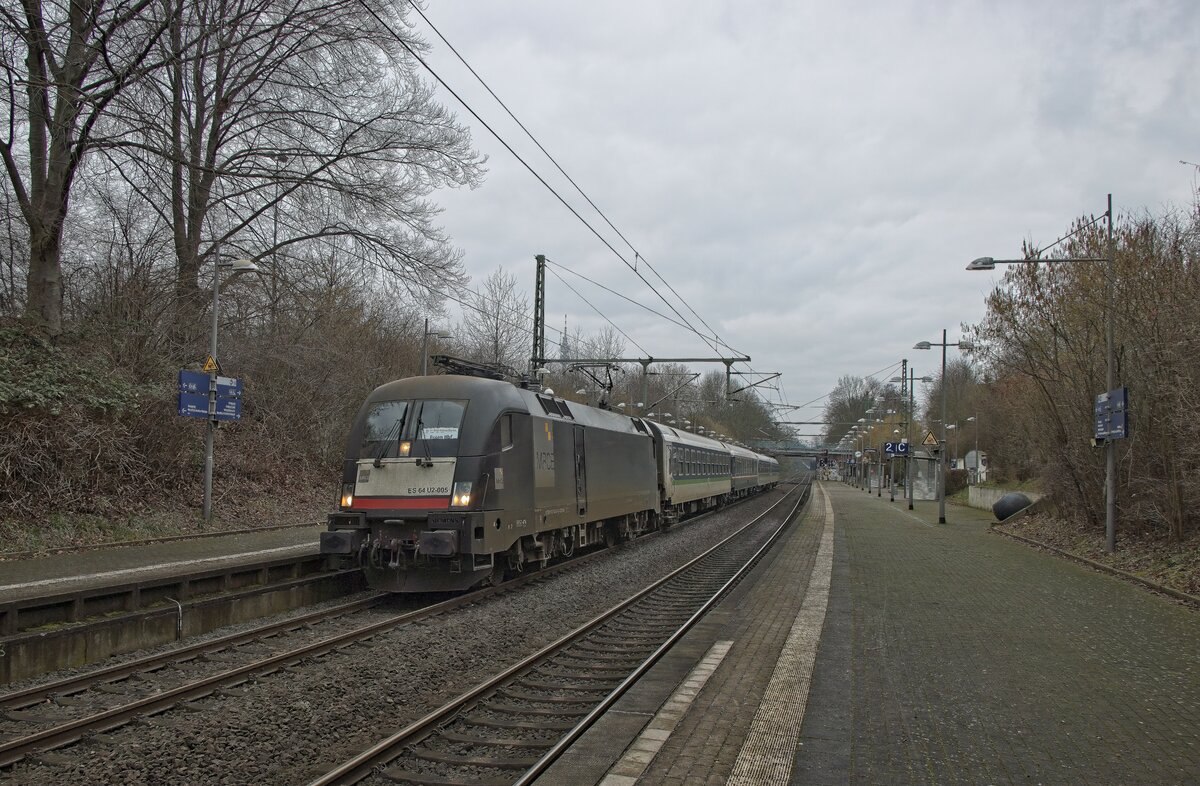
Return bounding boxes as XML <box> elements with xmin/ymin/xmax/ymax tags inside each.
<box><xmin>359</xmin><ymin>400</ymin><xmax>467</xmax><ymax>460</ymax></box>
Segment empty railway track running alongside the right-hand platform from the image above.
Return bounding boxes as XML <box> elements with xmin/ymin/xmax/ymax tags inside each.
<box><xmin>308</xmin><ymin>477</ymin><xmax>810</xmax><ymax>786</ymax></box>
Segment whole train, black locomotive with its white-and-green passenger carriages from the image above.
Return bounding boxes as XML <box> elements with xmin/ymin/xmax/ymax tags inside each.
<box><xmin>320</xmin><ymin>374</ymin><xmax>779</xmax><ymax>592</ymax></box>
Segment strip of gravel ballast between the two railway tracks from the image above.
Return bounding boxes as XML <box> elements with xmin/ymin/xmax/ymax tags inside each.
<box><xmin>7</xmin><ymin>490</ymin><xmax>793</xmax><ymax>786</ymax></box>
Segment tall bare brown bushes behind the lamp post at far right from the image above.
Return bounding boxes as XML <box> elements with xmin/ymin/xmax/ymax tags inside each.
<box><xmin>976</xmin><ymin>208</ymin><xmax>1200</xmax><ymax>540</ymax></box>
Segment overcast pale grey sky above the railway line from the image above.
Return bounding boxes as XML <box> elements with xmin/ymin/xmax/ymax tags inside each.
<box><xmin>413</xmin><ymin>0</ymin><xmax>1200</xmax><ymax>433</ymax></box>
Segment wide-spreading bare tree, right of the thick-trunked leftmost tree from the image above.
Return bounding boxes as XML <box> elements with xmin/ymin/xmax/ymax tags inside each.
<box><xmin>93</xmin><ymin>0</ymin><xmax>482</xmax><ymax>345</ymax></box>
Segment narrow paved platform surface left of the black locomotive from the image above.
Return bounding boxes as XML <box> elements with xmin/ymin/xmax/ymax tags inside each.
<box><xmin>0</xmin><ymin>524</ymin><xmax>325</xmax><ymax>602</ymax></box>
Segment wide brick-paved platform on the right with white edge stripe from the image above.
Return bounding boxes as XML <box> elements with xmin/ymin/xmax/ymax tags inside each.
<box><xmin>536</xmin><ymin>482</ymin><xmax>1200</xmax><ymax>786</ymax></box>
